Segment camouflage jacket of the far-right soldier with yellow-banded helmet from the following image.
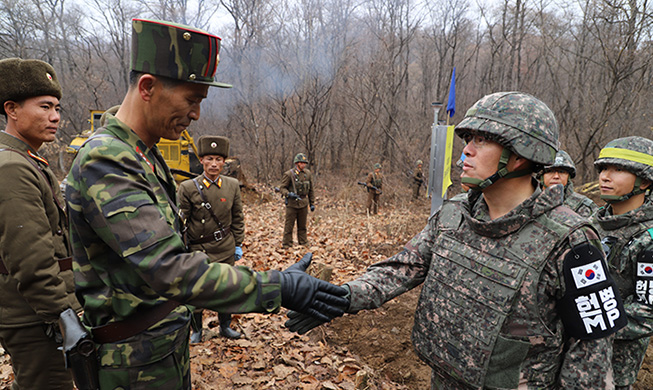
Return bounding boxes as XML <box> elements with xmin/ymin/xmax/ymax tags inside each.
<box><xmin>592</xmin><ymin>197</ymin><xmax>653</xmax><ymax>340</ymax></box>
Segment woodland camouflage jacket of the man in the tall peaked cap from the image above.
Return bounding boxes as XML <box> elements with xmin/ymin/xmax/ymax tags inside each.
<box><xmin>66</xmin><ymin>116</ymin><xmax>281</xmax><ymax>366</ymax></box>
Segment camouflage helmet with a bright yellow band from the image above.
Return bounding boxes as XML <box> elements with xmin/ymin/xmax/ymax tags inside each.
<box><xmin>594</xmin><ymin>136</ymin><xmax>653</xmax><ymax>181</ymax></box>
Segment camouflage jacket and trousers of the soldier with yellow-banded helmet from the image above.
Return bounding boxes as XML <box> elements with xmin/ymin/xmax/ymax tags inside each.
<box><xmin>593</xmin><ymin>197</ymin><xmax>653</xmax><ymax>386</ymax></box>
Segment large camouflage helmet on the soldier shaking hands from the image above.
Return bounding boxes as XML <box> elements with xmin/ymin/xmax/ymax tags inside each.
<box><xmin>456</xmin><ymin>92</ymin><xmax>558</xmax><ymax>165</ymax></box>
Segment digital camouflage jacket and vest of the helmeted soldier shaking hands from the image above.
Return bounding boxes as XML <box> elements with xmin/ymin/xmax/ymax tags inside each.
<box><xmin>347</xmin><ymin>186</ymin><xmax>612</xmax><ymax>389</ymax></box>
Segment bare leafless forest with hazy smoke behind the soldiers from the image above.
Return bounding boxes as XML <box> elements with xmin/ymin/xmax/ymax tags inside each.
<box><xmin>0</xmin><ymin>0</ymin><xmax>653</xmax><ymax>186</ymax></box>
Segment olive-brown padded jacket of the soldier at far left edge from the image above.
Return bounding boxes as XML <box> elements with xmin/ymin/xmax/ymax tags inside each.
<box><xmin>0</xmin><ymin>132</ymin><xmax>80</xmax><ymax>328</ymax></box>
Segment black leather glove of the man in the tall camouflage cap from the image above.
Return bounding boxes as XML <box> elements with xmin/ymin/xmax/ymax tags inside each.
<box><xmin>279</xmin><ymin>253</ymin><xmax>349</xmax><ymax>322</ymax></box>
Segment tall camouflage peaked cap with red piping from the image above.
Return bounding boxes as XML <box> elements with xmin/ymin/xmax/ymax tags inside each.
<box><xmin>131</xmin><ymin>19</ymin><xmax>231</xmax><ymax>88</ymax></box>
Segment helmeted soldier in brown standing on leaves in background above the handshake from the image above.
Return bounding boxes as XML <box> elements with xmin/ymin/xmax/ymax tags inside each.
<box><xmin>279</xmin><ymin>153</ymin><xmax>315</xmax><ymax>248</ymax></box>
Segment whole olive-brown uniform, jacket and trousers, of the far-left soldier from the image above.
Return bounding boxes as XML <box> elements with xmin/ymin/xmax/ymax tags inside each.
<box><xmin>0</xmin><ymin>132</ymin><xmax>80</xmax><ymax>389</ymax></box>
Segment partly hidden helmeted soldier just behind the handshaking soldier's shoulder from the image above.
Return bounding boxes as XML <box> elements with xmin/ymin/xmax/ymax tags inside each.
<box><xmin>540</xmin><ymin>150</ymin><xmax>599</xmax><ymax>218</ymax></box>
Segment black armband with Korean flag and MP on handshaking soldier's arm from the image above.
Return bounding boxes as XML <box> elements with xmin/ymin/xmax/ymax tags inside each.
<box><xmin>558</xmin><ymin>244</ymin><xmax>627</xmax><ymax>340</ymax></box>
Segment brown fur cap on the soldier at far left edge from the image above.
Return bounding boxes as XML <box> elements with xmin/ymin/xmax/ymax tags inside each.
<box><xmin>0</xmin><ymin>58</ymin><xmax>61</xmax><ymax>115</ymax></box>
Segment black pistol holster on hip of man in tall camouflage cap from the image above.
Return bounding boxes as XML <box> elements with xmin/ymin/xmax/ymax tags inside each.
<box><xmin>59</xmin><ymin>309</ymin><xmax>100</xmax><ymax>390</ymax></box>
